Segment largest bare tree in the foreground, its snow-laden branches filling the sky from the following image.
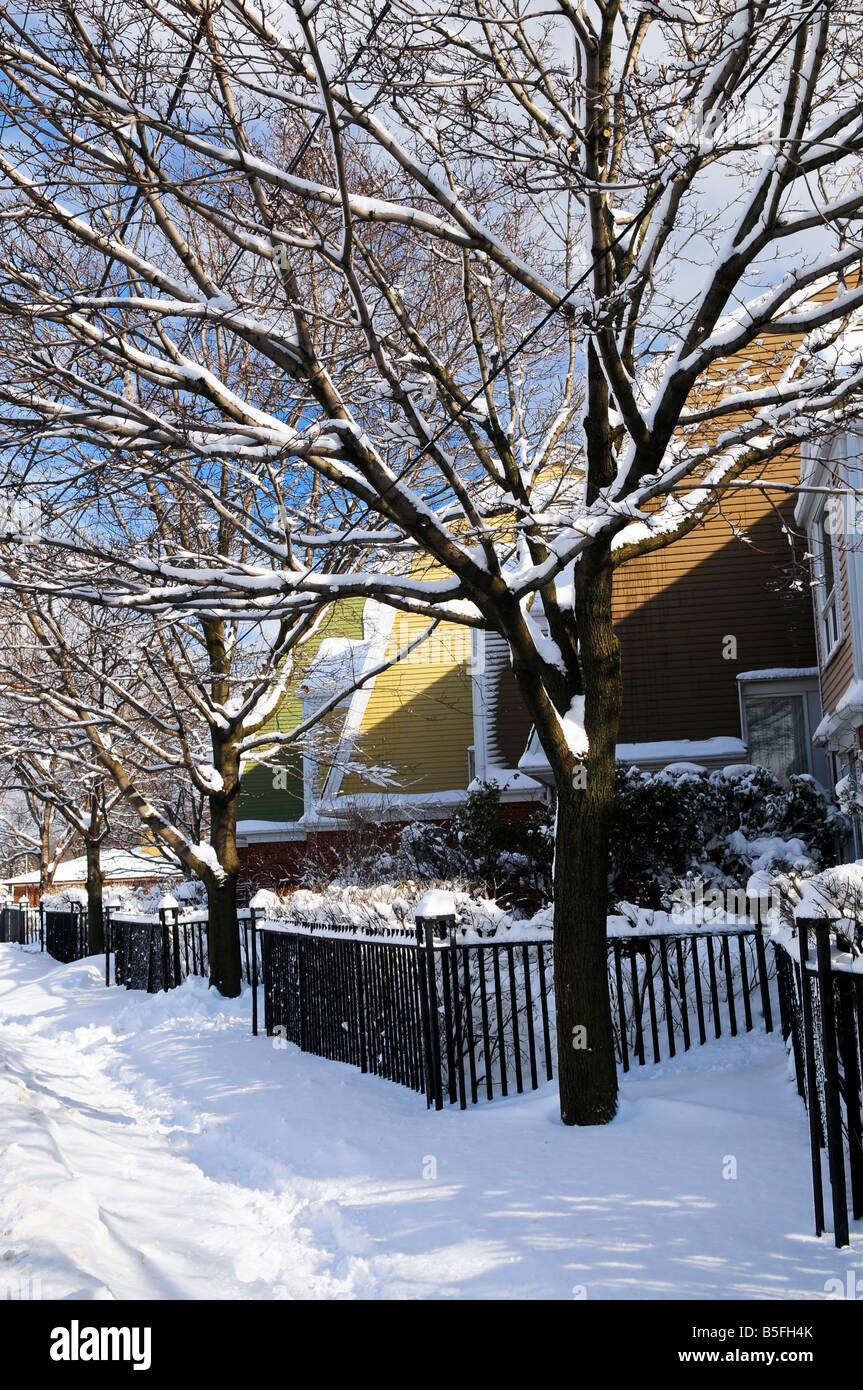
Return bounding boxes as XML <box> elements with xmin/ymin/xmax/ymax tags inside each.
<box><xmin>0</xmin><ymin>0</ymin><xmax>863</xmax><ymax>1123</ymax></box>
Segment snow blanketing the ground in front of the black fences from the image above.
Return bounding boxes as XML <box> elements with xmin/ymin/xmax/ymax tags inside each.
<box><xmin>0</xmin><ymin>947</ymin><xmax>863</xmax><ymax>1298</ymax></box>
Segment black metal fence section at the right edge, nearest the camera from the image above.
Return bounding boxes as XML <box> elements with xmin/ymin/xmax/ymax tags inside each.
<box><xmin>774</xmin><ymin>919</ymin><xmax>863</xmax><ymax>1247</ymax></box>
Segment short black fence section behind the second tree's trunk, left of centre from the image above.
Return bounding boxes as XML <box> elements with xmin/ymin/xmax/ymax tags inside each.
<box><xmin>104</xmin><ymin>908</ymin><xmax>253</xmax><ymax>994</ymax></box>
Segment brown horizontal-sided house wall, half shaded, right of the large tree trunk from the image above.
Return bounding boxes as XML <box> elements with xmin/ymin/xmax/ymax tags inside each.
<box><xmin>614</xmin><ymin>457</ymin><xmax>816</xmax><ymax>742</ymax></box>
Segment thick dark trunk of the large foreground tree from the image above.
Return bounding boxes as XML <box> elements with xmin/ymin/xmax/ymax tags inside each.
<box><xmin>554</xmin><ymin>547</ymin><xmax>621</xmax><ymax>1125</ymax></box>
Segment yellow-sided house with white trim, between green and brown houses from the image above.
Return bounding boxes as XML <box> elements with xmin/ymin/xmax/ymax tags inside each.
<box><xmin>238</xmin><ymin>599</ymin><xmax>546</xmax><ymax>878</ymax></box>
